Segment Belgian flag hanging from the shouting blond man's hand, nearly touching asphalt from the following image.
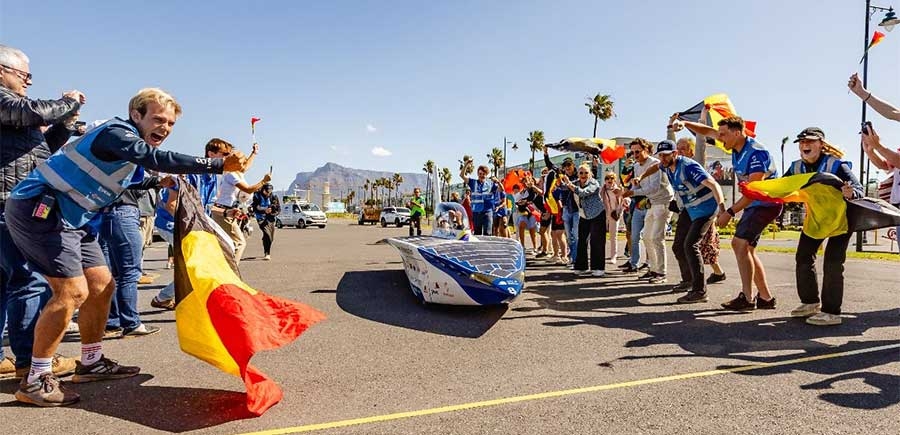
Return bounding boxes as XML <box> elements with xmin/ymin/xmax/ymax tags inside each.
<box><xmin>174</xmin><ymin>183</ymin><xmax>325</xmax><ymax>415</ymax></box>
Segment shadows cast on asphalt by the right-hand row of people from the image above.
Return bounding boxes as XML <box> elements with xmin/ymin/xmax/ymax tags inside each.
<box><xmin>504</xmin><ymin>273</ymin><xmax>900</xmax><ymax>409</ymax></box>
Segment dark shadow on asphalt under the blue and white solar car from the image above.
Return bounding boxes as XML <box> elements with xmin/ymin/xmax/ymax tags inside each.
<box><xmin>338</xmin><ymin>270</ymin><xmax>508</xmax><ymax>338</ymax></box>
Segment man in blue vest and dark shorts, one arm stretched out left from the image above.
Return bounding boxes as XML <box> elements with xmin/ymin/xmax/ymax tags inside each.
<box><xmin>676</xmin><ymin>116</ymin><xmax>782</xmax><ymax>311</ymax></box>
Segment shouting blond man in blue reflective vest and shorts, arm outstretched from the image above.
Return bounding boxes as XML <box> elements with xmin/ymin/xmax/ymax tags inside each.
<box><xmin>6</xmin><ymin>88</ymin><xmax>246</xmax><ymax>406</ymax></box>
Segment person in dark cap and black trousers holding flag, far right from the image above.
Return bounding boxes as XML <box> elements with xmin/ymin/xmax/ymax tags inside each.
<box><xmin>784</xmin><ymin>127</ymin><xmax>863</xmax><ymax>326</ymax></box>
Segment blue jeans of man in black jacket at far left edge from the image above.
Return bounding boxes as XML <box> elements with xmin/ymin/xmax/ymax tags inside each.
<box><xmin>0</xmin><ymin>210</ymin><xmax>52</xmax><ymax>368</ymax></box>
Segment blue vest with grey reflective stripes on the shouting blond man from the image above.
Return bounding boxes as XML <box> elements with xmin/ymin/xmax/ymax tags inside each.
<box><xmin>11</xmin><ymin>118</ymin><xmax>143</xmax><ymax>228</ymax></box>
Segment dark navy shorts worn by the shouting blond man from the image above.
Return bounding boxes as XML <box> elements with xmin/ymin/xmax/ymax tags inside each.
<box><xmin>6</xmin><ymin>197</ymin><xmax>106</xmax><ymax>278</ymax></box>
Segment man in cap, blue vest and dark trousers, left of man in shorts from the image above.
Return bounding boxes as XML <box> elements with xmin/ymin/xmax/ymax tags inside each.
<box><xmin>656</xmin><ymin>140</ymin><xmax>725</xmax><ymax>304</ymax></box>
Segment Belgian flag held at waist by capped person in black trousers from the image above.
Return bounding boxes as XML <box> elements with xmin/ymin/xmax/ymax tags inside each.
<box><xmin>741</xmin><ymin>172</ymin><xmax>900</xmax><ymax>239</ymax></box>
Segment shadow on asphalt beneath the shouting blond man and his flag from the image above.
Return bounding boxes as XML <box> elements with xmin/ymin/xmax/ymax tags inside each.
<box><xmin>0</xmin><ymin>374</ymin><xmax>254</xmax><ymax>433</ymax></box>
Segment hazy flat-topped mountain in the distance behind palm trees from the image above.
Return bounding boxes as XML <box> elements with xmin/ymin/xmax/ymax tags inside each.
<box><xmin>287</xmin><ymin>162</ymin><xmax>427</xmax><ymax>201</ymax></box>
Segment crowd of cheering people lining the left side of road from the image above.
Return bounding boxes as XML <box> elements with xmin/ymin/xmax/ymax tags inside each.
<box><xmin>0</xmin><ymin>45</ymin><xmax>280</xmax><ymax>406</ymax></box>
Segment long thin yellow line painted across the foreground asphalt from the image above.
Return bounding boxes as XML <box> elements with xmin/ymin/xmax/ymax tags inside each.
<box><xmin>241</xmin><ymin>344</ymin><xmax>900</xmax><ymax>435</ymax></box>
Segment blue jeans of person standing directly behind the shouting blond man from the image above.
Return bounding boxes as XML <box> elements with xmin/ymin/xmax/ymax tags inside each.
<box><xmin>100</xmin><ymin>205</ymin><xmax>143</xmax><ymax>330</ymax></box>
